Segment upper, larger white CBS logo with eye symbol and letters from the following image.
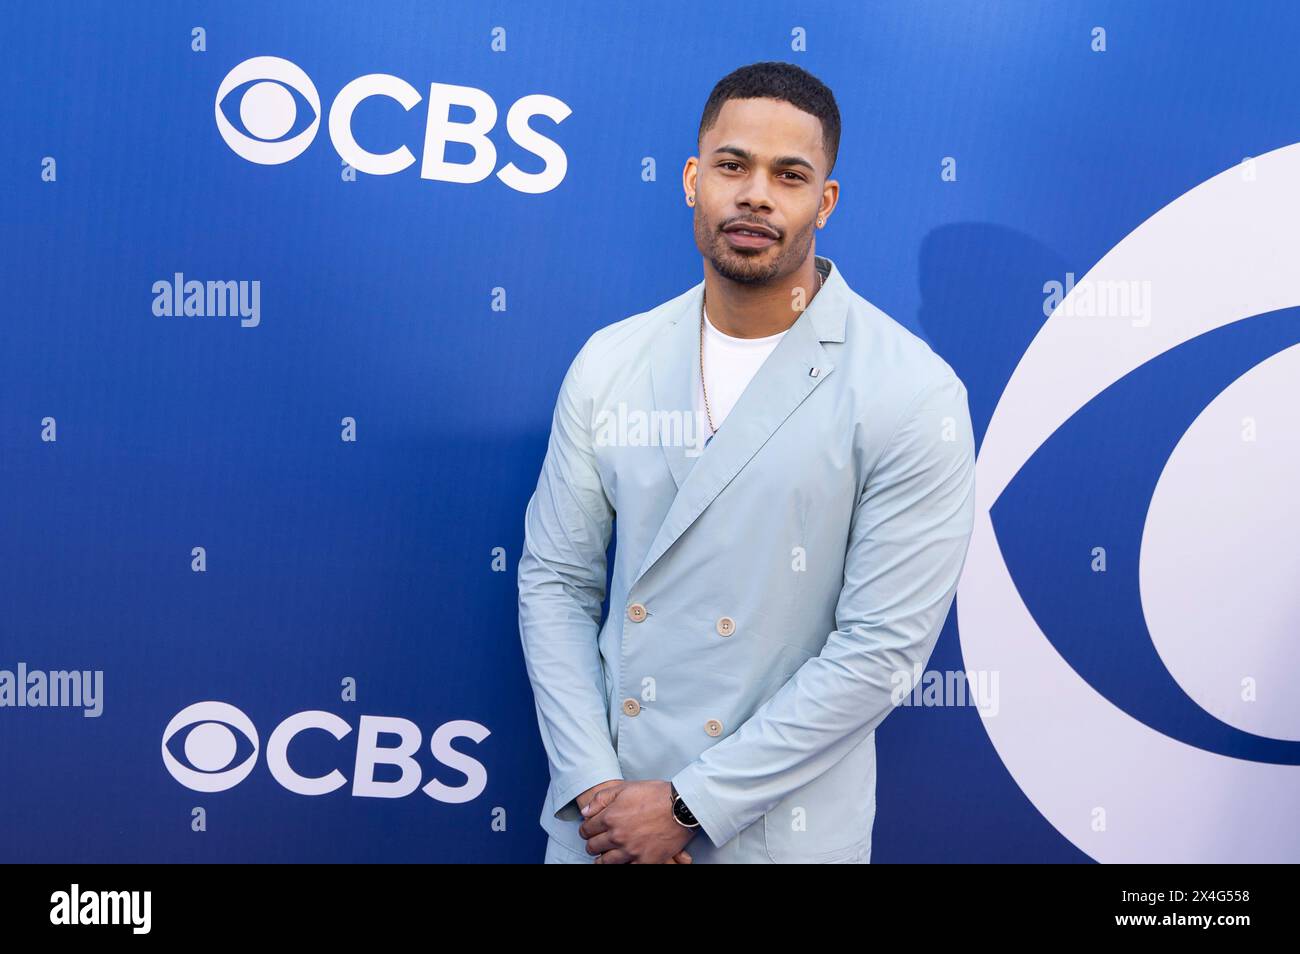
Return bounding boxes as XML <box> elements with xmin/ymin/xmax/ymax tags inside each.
<box><xmin>216</xmin><ymin>56</ymin><xmax>572</xmax><ymax>195</ymax></box>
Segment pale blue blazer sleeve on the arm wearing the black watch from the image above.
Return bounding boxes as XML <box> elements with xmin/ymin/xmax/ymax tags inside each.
<box><xmin>672</xmin><ymin>370</ymin><xmax>975</xmax><ymax>847</ymax></box>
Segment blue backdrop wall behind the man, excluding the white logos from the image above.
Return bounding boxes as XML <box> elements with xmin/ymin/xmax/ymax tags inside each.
<box><xmin>0</xmin><ymin>0</ymin><xmax>1300</xmax><ymax>862</ymax></box>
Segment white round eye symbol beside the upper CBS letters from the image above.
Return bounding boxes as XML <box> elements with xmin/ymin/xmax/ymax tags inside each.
<box><xmin>216</xmin><ymin>56</ymin><xmax>321</xmax><ymax>165</ymax></box>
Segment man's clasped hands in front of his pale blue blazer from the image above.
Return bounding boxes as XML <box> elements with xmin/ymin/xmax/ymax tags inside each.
<box><xmin>577</xmin><ymin>780</ymin><xmax>696</xmax><ymax>864</ymax></box>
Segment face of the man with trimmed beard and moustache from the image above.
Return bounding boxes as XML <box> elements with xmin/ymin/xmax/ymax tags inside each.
<box><xmin>694</xmin><ymin>99</ymin><xmax>827</xmax><ymax>285</ymax></box>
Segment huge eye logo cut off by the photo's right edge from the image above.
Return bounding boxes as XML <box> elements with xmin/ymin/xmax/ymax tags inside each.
<box><xmin>957</xmin><ymin>143</ymin><xmax>1300</xmax><ymax>864</ymax></box>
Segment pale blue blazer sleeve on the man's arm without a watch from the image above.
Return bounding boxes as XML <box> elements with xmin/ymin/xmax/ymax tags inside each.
<box><xmin>519</xmin><ymin>339</ymin><xmax>623</xmax><ymax>820</ymax></box>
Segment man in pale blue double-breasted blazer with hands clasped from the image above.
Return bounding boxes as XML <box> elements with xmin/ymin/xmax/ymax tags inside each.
<box><xmin>519</xmin><ymin>62</ymin><xmax>975</xmax><ymax>864</ymax></box>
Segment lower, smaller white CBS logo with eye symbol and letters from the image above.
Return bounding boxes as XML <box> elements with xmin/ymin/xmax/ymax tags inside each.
<box><xmin>163</xmin><ymin>702</ymin><xmax>491</xmax><ymax>803</ymax></box>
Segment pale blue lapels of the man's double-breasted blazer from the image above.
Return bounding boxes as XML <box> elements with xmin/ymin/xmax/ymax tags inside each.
<box><xmin>633</xmin><ymin>256</ymin><xmax>849</xmax><ymax>585</ymax></box>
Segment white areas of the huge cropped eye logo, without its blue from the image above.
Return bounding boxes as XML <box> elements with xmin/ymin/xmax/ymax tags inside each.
<box><xmin>957</xmin><ymin>144</ymin><xmax>1300</xmax><ymax>863</ymax></box>
